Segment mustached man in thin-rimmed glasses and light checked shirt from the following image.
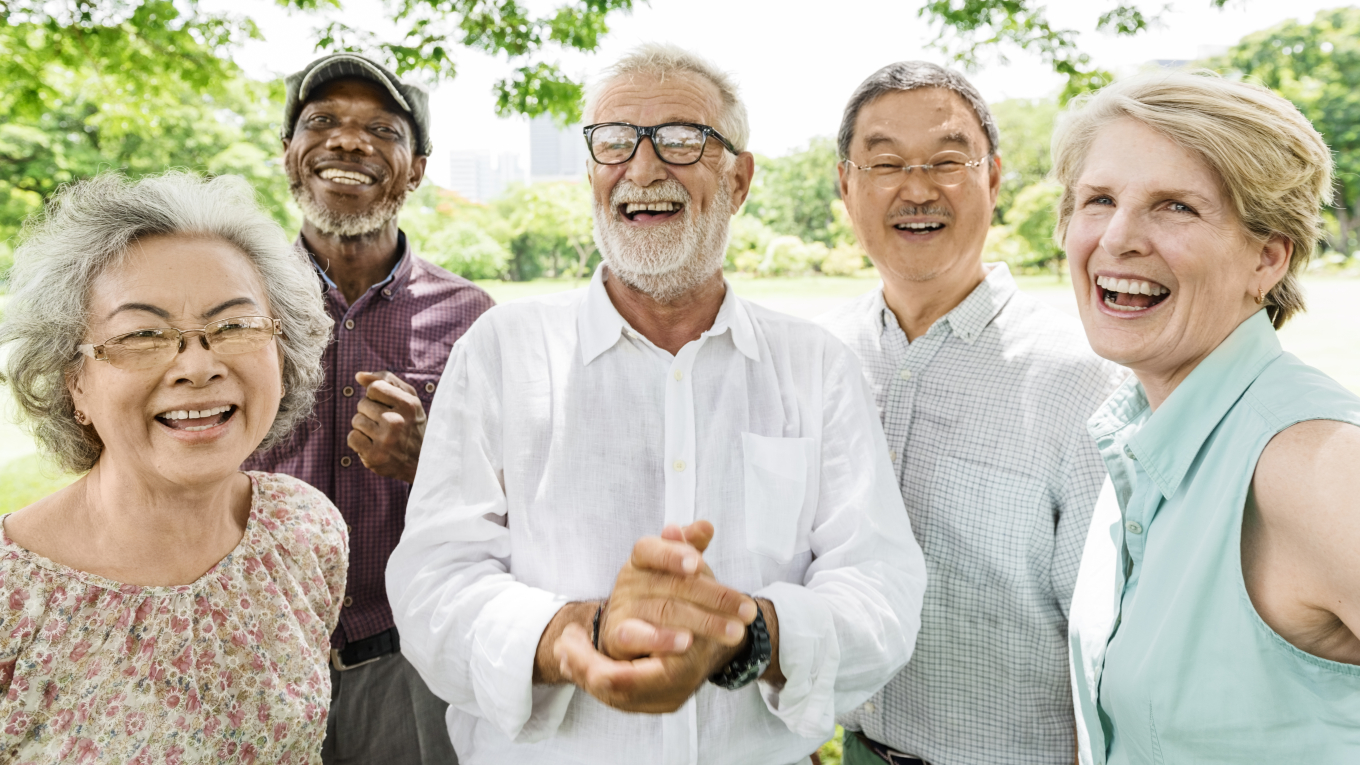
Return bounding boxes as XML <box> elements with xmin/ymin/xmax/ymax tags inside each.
<box><xmin>821</xmin><ymin>61</ymin><xmax>1123</xmax><ymax>765</ymax></box>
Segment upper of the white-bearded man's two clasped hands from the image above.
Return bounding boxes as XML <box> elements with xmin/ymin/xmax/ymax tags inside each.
<box><xmin>600</xmin><ymin>521</ymin><xmax>756</xmax><ymax>660</ymax></box>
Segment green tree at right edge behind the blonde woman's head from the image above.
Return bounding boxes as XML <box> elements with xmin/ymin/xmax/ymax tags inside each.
<box><xmin>1208</xmin><ymin>8</ymin><xmax>1360</xmax><ymax>255</ymax></box>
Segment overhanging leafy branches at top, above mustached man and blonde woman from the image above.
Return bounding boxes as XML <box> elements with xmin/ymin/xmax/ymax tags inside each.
<box><xmin>919</xmin><ymin>0</ymin><xmax>1228</xmax><ymax>102</ymax></box>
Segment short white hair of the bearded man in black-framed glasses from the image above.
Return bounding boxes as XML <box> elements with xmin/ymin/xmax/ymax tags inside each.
<box><xmin>583</xmin><ymin>42</ymin><xmax>751</xmax><ymax>151</ymax></box>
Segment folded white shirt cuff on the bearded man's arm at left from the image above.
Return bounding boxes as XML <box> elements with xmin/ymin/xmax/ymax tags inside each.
<box><xmin>469</xmin><ymin>587</ymin><xmax>577</xmax><ymax>743</ymax></box>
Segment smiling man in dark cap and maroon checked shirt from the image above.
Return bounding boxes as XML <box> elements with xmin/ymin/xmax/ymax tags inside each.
<box><xmin>248</xmin><ymin>53</ymin><xmax>492</xmax><ymax>765</ymax></box>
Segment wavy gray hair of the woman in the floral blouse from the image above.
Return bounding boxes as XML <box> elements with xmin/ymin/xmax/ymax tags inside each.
<box><xmin>0</xmin><ymin>172</ymin><xmax>332</xmax><ymax>472</ymax></box>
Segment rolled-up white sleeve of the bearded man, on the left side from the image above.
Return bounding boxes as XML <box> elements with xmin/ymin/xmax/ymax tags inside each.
<box><xmin>386</xmin><ymin>320</ymin><xmax>575</xmax><ymax>742</ymax></box>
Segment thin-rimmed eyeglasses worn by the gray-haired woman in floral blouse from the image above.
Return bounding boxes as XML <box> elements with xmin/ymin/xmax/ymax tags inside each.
<box><xmin>76</xmin><ymin>316</ymin><xmax>283</xmax><ymax>370</ymax></box>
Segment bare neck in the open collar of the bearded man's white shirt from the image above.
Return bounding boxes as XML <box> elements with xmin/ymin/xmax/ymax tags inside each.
<box><xmin>604</xmin><ymin>267</ymin><xmax>728</xmax><ymax>355</ymax></box>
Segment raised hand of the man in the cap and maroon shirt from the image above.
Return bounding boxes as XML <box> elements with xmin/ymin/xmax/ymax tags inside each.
<box><xmin>345</xmin><ymin>372</ymin><xmax>426</xmax><ymax>483</ymax></box>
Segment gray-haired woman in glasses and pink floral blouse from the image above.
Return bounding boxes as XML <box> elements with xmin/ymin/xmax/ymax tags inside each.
<box><xmin>0</xmin><ymin>174</ymin><xmax>348</xmax><ymax>764</ymax></box>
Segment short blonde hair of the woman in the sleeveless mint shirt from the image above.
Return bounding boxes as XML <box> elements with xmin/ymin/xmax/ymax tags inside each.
<box><xmin>1053</xmin><ymin>71</ymin><xmax>1333</xmax><ymax>329</ymax></box>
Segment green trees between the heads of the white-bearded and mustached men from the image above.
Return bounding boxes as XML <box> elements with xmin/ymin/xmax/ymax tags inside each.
<box><xmin>744</xmin><ymin>137</ymin><xmax>839</xmax><ymax>246</ymax></box>
